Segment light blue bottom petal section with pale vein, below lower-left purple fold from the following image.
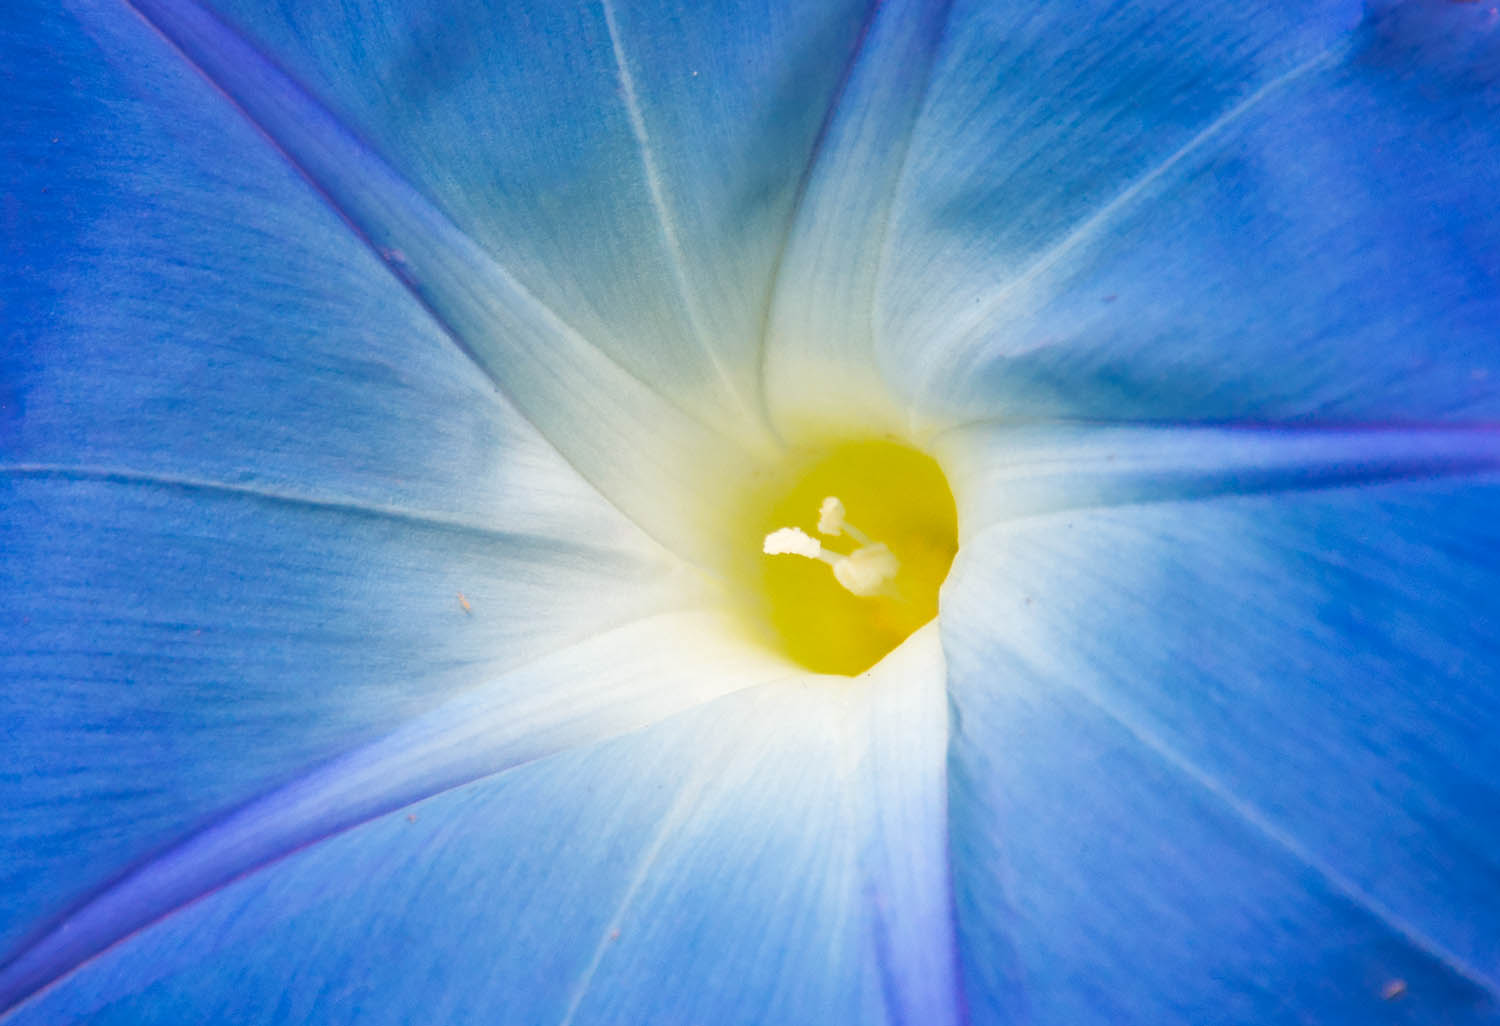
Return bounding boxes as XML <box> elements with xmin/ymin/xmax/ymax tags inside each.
<box><xmin>5</xmin><ymin>686</ymin><xmax>879</xmax><ymax>1026</ymax></box>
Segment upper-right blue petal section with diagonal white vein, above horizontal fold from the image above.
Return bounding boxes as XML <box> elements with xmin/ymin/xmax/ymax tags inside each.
<box><xmin>878</xmin><ymin>0</ymin><xmax>1500</xmax><ymax>423</ymax></box>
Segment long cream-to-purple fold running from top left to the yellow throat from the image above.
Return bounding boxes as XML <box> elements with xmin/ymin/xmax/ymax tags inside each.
<box><xmin>118</xmin><ymin>0</ymin><xmax>770</xmax><ymax>566</ymax></box>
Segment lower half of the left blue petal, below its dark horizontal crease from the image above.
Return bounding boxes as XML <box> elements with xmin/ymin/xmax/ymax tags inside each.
<box><xmin>0</xmin><ymin>476</ymin><xmax>687</xmax><ymax>984</ymax></box>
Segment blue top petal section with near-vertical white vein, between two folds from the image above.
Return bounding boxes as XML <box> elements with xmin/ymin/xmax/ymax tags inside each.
<box><xmin>198</xmin><ymin>0</ymin><xmax>872</xmax><ymax>438</ymax></box>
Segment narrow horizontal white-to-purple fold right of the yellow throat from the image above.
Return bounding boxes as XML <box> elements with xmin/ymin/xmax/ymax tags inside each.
<box><xmin>933</xmin><ymin>422</ymin><xmax>1500</xmax><ymax>545</ymax></box>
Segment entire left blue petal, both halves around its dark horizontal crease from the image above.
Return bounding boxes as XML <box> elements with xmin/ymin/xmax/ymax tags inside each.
<box><xmin>0</xmin><ymin>5</ymin><xmax>687</xmax><ymax>978</ymax></box>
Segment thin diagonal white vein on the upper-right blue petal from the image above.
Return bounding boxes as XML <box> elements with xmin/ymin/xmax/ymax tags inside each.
<box><xmin>909</xmin><ymin>41</ymin><xmax>1352</xmax><ymax>432</ymax></box>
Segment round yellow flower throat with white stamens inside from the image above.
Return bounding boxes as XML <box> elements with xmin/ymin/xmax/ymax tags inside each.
<box><xmin>732</xmin><ymin>441</ymin><xmax>959</xmax><ymax>677</ymax></box>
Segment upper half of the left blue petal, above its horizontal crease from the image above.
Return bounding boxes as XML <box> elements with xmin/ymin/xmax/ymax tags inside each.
<box><xmin>0</xmin><ymin>5</ymin><xmax>629</xmax><ymax>542</ymax></box>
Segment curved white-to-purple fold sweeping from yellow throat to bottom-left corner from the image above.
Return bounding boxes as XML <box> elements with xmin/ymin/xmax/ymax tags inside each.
<box><xmin>0</xmin><ymin>614</ymin><xmax>789</xmax><ymax>1014</ymax></box>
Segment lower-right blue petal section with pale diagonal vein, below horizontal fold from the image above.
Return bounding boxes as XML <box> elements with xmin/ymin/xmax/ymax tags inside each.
<box><xmin>942</xmin><ymin>473</ymin><xmax>1500</xmax><ymax>1026</ymax></box>
